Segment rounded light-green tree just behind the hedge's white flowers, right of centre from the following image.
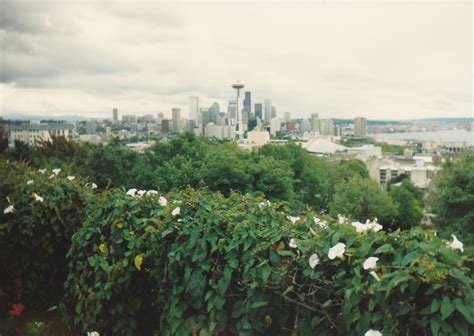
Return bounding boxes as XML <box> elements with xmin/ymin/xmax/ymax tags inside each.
<box><xmin>330</xmin><ymin>176</ymin><xmax>397</xmax><ymax>225</ymax></box>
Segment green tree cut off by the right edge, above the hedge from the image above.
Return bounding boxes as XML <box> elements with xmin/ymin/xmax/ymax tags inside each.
<box><xmin>429</xmin><ymin>155</ymin><xmax>474</xmax><ymax>244</ymax></box>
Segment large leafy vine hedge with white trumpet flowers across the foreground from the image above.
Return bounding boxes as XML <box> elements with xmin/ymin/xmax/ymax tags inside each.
<box><xmin>68</xmin><ymin>189</ymin><xmax>474</xmax><ymax>335</ymax></box>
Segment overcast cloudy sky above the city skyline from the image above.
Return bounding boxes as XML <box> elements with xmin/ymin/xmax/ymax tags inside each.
<box><xmin>0</xmin><ymin>0</ymin><xmax>474</xmax><ymax>120</ymax></box>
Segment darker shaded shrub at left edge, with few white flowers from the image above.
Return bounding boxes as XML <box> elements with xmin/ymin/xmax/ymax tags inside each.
<box><xmin>0</xmin><ymin>161</ymin><xmax>92</xmax><ymax>306</ymax></box>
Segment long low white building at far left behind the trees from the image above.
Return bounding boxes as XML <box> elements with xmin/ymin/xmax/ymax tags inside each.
<box><xmin>8</xmin><ymin>123</ymin><xmax>74</xmax><ymax>147</ymax></box>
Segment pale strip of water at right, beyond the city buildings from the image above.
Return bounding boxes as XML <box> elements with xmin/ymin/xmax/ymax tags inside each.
<box><xmin>370</xmin><ymin>129</ymin><xmax>474</xmax><ymax>145</ymax></box>
